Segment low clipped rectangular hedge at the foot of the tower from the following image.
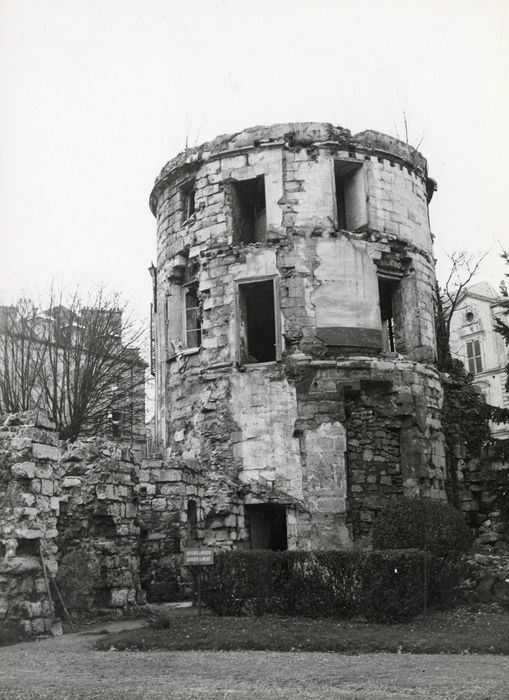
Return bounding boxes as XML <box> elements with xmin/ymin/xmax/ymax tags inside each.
<box><xmin>202</xmin><ymin>550</ymin><xmax>458</xmax><ymax>622</ymax></box>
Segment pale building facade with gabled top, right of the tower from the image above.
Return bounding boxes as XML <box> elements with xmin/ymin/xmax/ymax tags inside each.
<box><xmin>450</xmin><ymin>282</ymin><xmax>509</xmax><ymax>438</ymax></box>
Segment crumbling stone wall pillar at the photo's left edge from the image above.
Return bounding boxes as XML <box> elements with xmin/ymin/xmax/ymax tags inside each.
<box><xmin>0</xmin><ymin>413</ymin><xmax>60</xmax><ymax>635</ymax></box>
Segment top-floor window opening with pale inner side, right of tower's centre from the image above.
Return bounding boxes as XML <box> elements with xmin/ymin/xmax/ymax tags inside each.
<box><xmin>334</xmin><ymin>160</ymin><xmax>368</xmax><ymax>231</ymax></box>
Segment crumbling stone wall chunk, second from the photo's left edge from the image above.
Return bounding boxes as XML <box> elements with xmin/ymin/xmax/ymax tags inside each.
<box><xmin>57</xmin><ymin>438</ymin><xmax>142</xmax><ymax>611</ymax></box>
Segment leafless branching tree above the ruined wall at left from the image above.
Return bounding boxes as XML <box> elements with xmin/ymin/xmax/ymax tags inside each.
<box><xmin>2</xmin><ymin>289</ymin><xmax>146</xmax><ymax>439</ymax></box>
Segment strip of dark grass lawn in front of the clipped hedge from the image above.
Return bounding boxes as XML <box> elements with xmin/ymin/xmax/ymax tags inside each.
<box><xmin>96</xmin><ymin>608</ymin><xmax>509</xmax><ymax>654</ymax></box>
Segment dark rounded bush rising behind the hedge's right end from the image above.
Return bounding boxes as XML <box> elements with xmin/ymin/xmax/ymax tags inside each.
<box><xmin>373</xmin><ymin>498</ymin><xmax>472</xmax><ymax>557</ymax></box>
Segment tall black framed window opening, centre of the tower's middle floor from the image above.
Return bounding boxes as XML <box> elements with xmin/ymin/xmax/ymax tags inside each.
<box><xmin>239</xmin><ymin>279</ymin><xmax>278</xmax><ymax>364</ymax></box>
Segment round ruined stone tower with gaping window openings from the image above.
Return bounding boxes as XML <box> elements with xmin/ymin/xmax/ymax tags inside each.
<box><xmin>146</xmin><ymin>123</ymin><xmax>445</xmax><ymax>554</ymax></box>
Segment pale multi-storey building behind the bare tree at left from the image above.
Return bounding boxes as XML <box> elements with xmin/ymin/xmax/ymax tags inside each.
<box><xmin>0</xmin><ymin>300</ymin><xmax>147</xmax><ymax>448</ymax></box>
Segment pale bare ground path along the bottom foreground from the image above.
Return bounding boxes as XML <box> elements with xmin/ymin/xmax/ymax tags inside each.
<box><xmin>0</xmin><ymin>625</ymin><xmax>509</xmax><ymax>700</ymax></box>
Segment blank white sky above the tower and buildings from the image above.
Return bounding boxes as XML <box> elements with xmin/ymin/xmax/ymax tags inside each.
<box><xmin>0</xmin><ymin>0</ymin><xmax>509</xmax><ymax>314</ymax></box>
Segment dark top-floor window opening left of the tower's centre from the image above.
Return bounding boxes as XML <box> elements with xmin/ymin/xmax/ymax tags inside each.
<box><xmin>232</xmin><ymin>175</ymin><xmax>267</xmax><ymax>243</ymax></box>
